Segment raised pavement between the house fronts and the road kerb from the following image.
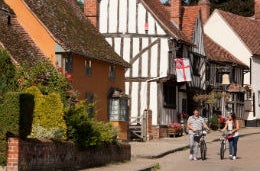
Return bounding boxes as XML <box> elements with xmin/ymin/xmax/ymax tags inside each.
<box><xmin>85</xmin><ymin>127</ymin><xmax>260</xmax><ymax>171</ymax></box>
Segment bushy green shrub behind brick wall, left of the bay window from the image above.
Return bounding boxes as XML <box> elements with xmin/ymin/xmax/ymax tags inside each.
<box><xmin>65</xmin><ymin>101</ymin><xmax>117</xmax><ymax>149</ymax></box>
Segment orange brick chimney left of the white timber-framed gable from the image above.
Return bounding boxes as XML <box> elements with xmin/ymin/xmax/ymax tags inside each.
<box><xmin>84</xmin><ymin>0</ymin><xmax>100</xmax><ymax>28</ymax></box>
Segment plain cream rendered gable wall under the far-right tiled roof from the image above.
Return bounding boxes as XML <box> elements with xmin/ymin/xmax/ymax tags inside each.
<box><xmin>204</xmin><ymin>11</ymin><xmax>252</xmax><ymax>84</ymax></box>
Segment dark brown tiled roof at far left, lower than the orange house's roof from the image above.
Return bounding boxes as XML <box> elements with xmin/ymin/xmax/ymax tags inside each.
<box><xmin>0</xmin><ymin>0</ymin><xmax>45</xmax><ymax>64</ymax></box>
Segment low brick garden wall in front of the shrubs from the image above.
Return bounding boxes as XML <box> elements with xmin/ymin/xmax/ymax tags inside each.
<box><xmin>7</xmin><ymin>138</ymin><xmax>131</xmax><ymax>171</ymax></box>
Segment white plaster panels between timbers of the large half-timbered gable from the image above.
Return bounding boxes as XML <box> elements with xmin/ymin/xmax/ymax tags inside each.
<box><xmin>99</xmin><ymin>0</ymin><xmax>169</xmax><ymax>125</ymax></box>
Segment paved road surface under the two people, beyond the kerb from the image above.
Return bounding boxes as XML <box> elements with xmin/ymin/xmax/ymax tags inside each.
<box><xmin>154</xmin><ymin>134</ymin><xmax>260</xmax><ymax>171</ymax></box>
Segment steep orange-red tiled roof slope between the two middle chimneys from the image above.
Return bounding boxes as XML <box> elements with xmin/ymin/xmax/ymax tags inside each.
<box><xmin>182</xmin><ymin>6</ymin><xmax>200</xmax><ymax>40</ymax></box>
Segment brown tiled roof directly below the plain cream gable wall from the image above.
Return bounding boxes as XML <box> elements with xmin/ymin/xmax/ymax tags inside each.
<box><xmin>204</xmin><ymin>35</ymin><xmax>248</xmax><ymax>68</ymax></box>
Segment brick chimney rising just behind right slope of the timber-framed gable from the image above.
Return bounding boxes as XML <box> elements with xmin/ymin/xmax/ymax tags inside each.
<box><xmin>162</xmin><ymin>0</ymin><xmax>181</xmax><ymax>28</ymax></box>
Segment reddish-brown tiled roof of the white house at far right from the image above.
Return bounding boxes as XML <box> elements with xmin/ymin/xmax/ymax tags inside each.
<box><xmin>217</xmin><ymin>10</ymin><xmax>260</xmax><ymax>55</ymax></box>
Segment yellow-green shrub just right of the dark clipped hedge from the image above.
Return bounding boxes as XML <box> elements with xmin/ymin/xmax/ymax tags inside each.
<box><xmin>25</xmin><ymin>86</ymin><xmax>67</xmax><ymax>140</ymax></box>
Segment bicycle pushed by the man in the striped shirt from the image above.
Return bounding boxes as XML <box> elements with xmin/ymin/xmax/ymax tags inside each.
<box><xmin>194</xmin><ymin>130</ymin><xmax>207</xmax><ymax>160</ymax></box>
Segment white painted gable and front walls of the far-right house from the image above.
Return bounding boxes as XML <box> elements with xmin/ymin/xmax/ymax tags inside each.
<box><xmin>204</xmin><ymin>11</ymin><xmax>260</xmax><ymax>120</ymax></box>
